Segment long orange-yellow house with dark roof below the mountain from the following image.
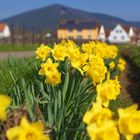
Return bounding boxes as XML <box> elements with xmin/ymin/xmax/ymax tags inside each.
<box><xmin>57</xmin><ymin>20</ymin><xmax>99</xmax><ymax>40</ymax></box>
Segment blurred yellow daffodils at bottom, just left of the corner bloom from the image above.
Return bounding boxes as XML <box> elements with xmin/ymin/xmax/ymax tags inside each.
<box><xmin>83</xmin><ymin>102</ymin><xmax>120</xmax><ymax>140</ymax></box>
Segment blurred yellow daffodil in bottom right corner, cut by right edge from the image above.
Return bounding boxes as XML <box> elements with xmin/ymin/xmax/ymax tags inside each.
<box><xmin>118</xmin><ymin>104</ymin><xmax>140</xmax><ymax>140</ymax></box>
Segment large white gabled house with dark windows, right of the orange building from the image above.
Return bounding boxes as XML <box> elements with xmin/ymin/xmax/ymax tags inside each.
<box><xmin>108</xmin><ymin>24</ymin><xmax>132</xmax><ymax>43</ymax></box>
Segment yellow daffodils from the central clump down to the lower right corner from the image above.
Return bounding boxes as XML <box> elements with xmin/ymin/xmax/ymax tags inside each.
<box><xmin>36</xmin><ymin>40</ymin><xmax>140</xmax><ymax>140</ymax></box>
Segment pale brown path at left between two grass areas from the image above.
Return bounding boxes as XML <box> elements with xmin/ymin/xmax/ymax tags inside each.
<box><xmin>0</xmin><ymin>51</ymin><xmax>35</xmax><ymax>59</ymax></box>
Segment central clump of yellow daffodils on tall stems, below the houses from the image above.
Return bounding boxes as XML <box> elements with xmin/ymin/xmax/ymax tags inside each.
<box><xmin>36</xmin><ymin>40</ymin><xmax>121</xmax><ymax>85</ymax></box>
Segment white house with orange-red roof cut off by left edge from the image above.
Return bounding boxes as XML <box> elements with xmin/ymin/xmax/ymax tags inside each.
<box><xmin>0</xmin><ymin>23</ymin><xmax>11</xmax><ymax>38</ymax></box>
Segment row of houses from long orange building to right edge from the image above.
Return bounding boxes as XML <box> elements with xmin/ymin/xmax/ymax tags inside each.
<box><xmin>57</xmin><ymin>21</ymin><xmax>140</xmax><ymax>45</ymax></box>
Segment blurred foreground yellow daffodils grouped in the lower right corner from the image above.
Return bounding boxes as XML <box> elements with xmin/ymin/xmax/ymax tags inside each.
<box><xmin>83</xmin><ymin>102</ymin><xmax>140</xmax><ymax>140</ymax></box>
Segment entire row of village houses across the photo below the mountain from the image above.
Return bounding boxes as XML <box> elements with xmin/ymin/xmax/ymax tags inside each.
<box><xmin>0</xmin><ymin>20</ymin><xmax>140</xmax><ymax>46</ymax></box>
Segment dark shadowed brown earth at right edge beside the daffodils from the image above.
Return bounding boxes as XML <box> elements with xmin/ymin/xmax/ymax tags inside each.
<box><xmin>121</xmin><ymin>58</ymin><xmax>140</xmax><ymax>106</ymax></box>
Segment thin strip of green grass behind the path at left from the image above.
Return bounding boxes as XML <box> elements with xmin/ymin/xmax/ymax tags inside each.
<box><xmin>0</xmin><ymin>44</ymin><xmax>38</xmax><ymax>52</ymax></box>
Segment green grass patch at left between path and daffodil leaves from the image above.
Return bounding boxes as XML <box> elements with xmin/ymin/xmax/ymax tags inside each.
<box><xmin>0</xmin><ymin>57</ymin><xmax>38</xmax><ymax>94</ymax></box>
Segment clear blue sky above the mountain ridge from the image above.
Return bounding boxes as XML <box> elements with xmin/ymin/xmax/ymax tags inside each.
<box><xmin>0</xmin><ymin>0</ymin><xmax>140</xmax><ymax>21</ymax></box>
